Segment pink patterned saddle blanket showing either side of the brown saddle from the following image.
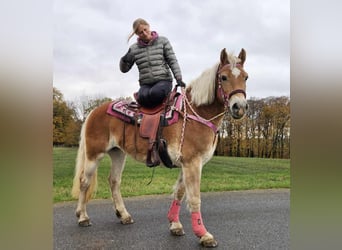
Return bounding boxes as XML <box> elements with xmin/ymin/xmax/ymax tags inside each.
<box><xmin>107</xmin><ymin>95</ymin><xmax>182</xmax><ymax>126</ymax></box>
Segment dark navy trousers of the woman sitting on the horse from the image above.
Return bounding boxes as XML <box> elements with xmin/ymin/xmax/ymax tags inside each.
<box><xmin>138</xmin><ymin>81</ymin><xmax>172</xmax><ymax>108</ymax></box>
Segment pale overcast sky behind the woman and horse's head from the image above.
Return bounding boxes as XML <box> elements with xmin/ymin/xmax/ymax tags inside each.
<box><xmin>53</xmin><ymin>0</ymin><xmax>290</xmax><ymax>101</ymax></box>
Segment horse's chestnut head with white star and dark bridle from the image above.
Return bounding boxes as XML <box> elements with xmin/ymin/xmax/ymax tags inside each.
<box><xmin>217</xmin><ymin>49</ymin><xmax>248</xmax><ymax>119</ymax></box>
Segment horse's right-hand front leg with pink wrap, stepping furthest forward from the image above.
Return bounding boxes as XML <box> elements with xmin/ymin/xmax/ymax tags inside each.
<box><xmin>183</xmin><ymin>160</ymin><xmax>217</xmax><ymax>247</ymax></box>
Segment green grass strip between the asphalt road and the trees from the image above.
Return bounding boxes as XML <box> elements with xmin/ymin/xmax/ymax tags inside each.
<box><xmin>53</xmin><ymin>148</ymin><xmax>290</xmax><ymax>202</ymax></box>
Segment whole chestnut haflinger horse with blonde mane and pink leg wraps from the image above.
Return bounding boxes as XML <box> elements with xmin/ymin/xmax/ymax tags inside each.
<box><xmin>72</xmin><ymin>49</ymin><xmax>248</xmax><ymax>247</ymax></box>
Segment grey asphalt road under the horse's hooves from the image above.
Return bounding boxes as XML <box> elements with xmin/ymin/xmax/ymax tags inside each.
<box><xmin>53</xmin><ymin>189</ymin><xmax>290</xmax><ymax>250</ymax></box>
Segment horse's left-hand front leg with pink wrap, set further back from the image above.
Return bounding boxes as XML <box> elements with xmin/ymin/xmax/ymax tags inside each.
<box><xmin>167</xmin><ymin>172</ymin><xmax>185</xmax><ymax>236</ymax></box>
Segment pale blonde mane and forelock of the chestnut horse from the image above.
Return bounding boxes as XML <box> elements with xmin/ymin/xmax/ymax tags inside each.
<box><xmin>188</xmin><ymin>53</ymin><xmax>241</xmax><ymax>107</ymax></box>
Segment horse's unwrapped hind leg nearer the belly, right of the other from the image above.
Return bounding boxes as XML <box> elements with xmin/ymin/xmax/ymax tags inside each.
<box><xmin>108</xmin><ymin>149</ymin><xmax>134</xmax><ymax>224</ymax></box>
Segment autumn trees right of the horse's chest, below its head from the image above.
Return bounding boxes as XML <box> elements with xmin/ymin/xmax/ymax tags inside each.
<box><xmin>215</xmin><ymin>96</ymin><xmax>291</xmax><ymax>158</ymax></box>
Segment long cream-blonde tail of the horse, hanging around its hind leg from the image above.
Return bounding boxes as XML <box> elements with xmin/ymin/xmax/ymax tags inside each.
<box><xmin>71</xmin><ymin>114</ymin><xmax>97</xmax><ymax>201</ymax></box>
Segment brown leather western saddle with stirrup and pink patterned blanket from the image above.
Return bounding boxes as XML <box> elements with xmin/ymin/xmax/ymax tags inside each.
<box><xmin>107</xmin><ymin>88</ymin><xmax>182</xmax><ymax>168</ymax></box>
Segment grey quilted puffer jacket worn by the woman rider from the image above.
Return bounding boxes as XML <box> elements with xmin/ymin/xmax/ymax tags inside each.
<box><xmin>120</xmin><ymin>36</ymin><xmax>182</xmax><ymax>85</ymax></box>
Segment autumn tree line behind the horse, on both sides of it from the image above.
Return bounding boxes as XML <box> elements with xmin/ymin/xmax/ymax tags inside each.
<box><xmin>53</xmin><ymin>87</ymin><xmax>291</xmax><ymax>158</ymax></box>
